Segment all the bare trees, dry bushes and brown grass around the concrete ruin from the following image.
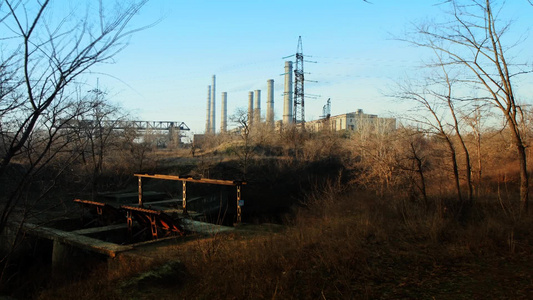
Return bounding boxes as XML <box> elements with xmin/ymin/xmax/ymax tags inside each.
<box><xmin>0</xmin><ymin>1</ymin><xmax>533</xmax><ymax>299</ymax></box>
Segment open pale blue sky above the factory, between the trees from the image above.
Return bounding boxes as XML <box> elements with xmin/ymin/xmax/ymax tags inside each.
<box><xmin>6</xmin><ymin>0</ymin><xmax>533</xmax><ymax>133</ymax></box>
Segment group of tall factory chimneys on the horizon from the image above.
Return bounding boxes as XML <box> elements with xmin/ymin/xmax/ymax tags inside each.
<box><xmin>205</xmin><ymin>61</ymin><xmax>293</xmax><ymax>134</ymax></box>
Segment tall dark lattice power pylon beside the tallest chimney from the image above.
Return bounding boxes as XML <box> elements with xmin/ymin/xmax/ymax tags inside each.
<box><xmin>292</xmin><ymin>36</ymin><xmax>305</xmax><ymax>127</ymax></box>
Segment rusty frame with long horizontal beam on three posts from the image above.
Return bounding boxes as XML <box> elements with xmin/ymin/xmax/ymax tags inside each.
<box><xmin>134</xmin><ymin>174</ymin><xmax>246</xmax><ymax>224</ymax></box>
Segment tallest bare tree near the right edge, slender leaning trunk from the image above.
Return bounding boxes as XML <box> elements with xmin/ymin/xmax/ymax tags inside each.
<box><xmin>409</xmin><ymin>0</ymin><xmax>529</xmax><ymax>211</ymax></box>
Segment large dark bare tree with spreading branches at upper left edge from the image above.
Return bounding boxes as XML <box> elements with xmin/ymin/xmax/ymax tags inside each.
<box><xmin>0</xmin><ymin>0</ymin><xmax>146</xmax><ymax>176</ymax></box>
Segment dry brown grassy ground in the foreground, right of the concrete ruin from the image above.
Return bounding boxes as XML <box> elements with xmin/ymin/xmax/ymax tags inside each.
<box><xmin>40</xmin><ymin>185</ymin><xmax>533</xmax><ymax>299</ymax></box>
